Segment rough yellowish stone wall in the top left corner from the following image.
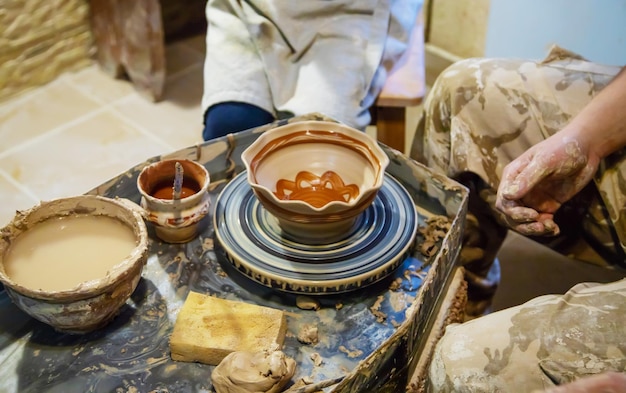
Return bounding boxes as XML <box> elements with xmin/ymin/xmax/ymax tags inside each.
<box><xmin>0</xmin><ymin>0</ymin><xmax>94</xmax><ymax>101</ymax></box>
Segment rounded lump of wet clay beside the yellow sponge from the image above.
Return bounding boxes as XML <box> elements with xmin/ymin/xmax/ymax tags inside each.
<box><xmin>211</xmin><ymin>351</ymin><xmax>296</xmax><ymax>393</ymax></box>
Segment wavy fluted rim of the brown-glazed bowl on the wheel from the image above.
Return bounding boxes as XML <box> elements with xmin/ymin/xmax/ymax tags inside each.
<box><xmin>241</xmin><ymin>120</ymin><xmax>390</xmax><ymax>214</ymax></box>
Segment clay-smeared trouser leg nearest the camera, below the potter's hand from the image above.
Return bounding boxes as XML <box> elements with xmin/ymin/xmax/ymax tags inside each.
<box><xmin>429</xmin><ymin>279</ymin><xmax>626</xmax><ymax>392</ymax></box>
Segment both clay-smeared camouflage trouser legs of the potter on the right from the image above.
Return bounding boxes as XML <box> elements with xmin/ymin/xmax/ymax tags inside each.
<box><xmin>411</xmin><ymin>48</ymin><xmax>626</xmax><ymax>392</ymax></box>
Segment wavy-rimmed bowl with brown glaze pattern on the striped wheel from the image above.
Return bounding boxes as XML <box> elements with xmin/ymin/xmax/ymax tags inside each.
<box><xmin>242</xmin><ymin>121</ymin><xmax>389</xmax><ymax>244</ymax></box>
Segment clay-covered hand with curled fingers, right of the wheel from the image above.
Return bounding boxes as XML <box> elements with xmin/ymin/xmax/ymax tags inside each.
<box><xmin>496</xmin><ymin>133</ymin><xmax>600</xmax><ymax>236</ymax></box>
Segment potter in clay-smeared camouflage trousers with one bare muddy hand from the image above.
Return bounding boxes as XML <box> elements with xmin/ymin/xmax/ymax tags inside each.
<box><xmin>411</xmin><ymin>47</ymin><xmax>626</xmax><ymax>392</ymax></box>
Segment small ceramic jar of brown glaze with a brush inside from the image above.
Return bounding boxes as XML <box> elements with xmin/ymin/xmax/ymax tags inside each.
<box><xmin>137</xmin><ymin>159</ymin><xmax>210</xmax><ymax>243</ymax></box>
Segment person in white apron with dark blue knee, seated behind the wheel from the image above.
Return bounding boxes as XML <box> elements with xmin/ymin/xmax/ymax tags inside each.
<box><xmin>202</xmin><ymin>0</ymin><xmax>423</xmax><ymax>141</ymax></box>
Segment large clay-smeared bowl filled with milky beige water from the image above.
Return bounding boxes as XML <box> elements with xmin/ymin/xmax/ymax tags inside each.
<box><xmin>0</xmin><ymin>195</ymin><xmax>148</xmax><ymax>333</ymax></box>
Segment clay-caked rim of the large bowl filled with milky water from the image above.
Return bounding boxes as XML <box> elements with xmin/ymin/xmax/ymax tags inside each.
<box><xmin>0</xmin><ymin>194</ymin><xmax>149</xmax><ymax>302</ymax></box>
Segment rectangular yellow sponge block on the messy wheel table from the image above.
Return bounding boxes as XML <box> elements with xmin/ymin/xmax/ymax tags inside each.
<box><xmin>170</xmin><ymin>292</ymin><xmax>287</xmax><ymax>366</ymax></box>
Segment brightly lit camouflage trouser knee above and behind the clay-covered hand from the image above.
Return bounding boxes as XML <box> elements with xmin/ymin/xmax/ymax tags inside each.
<box><xmin>412</xmin><ymin>47</ymin><xmax>620</xmax><ymax>193</ymax></box>
